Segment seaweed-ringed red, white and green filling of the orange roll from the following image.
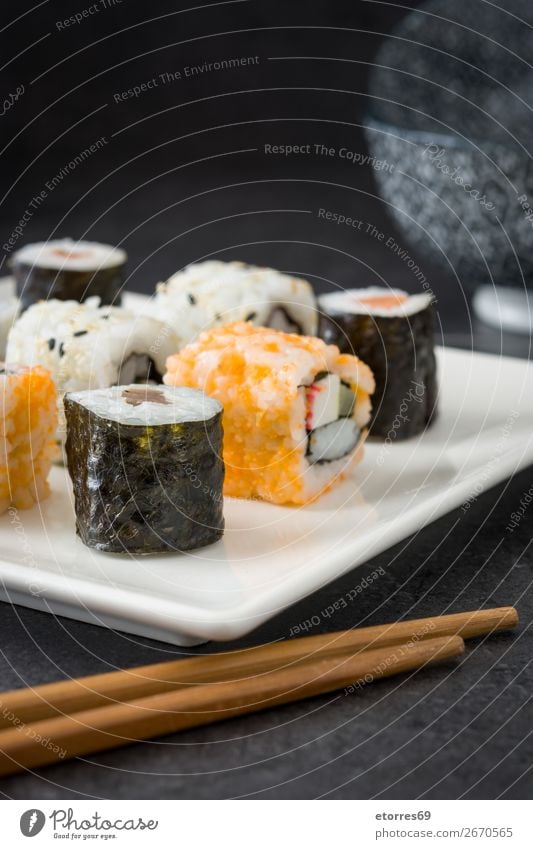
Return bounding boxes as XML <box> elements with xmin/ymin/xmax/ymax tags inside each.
<box><xmin>305</xmin><ymin>372</ymin><xmax>361</xmax><ymax>463</ymax></box>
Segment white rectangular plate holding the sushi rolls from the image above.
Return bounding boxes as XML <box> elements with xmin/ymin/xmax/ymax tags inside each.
<box><xmin>0</xmin><ymin>342</ymin><xmax>533</xmax><ymax>645</ymax></box>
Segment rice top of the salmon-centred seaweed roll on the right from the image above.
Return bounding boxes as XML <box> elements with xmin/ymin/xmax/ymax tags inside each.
<box><xmin>318</xmin><ymin>286</ymin><xmax>433</xmax><ymax>318</ymax></box>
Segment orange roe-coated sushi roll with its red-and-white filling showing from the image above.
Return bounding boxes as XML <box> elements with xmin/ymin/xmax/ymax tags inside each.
<box><xmin>165</xmin><ymin>322</ymin><xmax>374</xmax><ymax>504</ymax></box>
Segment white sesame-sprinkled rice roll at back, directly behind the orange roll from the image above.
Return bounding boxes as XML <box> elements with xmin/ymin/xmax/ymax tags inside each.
<box><xmin>149</xmin><ymin>261</ymin><xmax>318</xmax><ymax>347</ymax></box>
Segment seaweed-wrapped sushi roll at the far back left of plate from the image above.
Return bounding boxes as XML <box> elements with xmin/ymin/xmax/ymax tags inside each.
<box><xmin>11</xmin><ymin>239</ymin><xmax>126</xmax><ymax>309</ymax></box>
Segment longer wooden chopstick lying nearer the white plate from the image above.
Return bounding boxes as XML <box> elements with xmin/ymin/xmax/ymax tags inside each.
<box><xmin>0</xmin><ymin>607</ymin><xmax>518</xmax><ymax>729</ymax></box>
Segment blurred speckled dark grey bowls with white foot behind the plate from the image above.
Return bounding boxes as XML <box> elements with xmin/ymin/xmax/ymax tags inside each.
<box><xmin>366</xmin><ymin>0</ymin><xmax>533</xmax><ymax>331</ymax></box>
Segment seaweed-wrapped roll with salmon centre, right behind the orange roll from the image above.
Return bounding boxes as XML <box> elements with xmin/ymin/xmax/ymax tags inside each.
<box><xmin>318</xmin><ymin>287</ymin><xmax>437</xmax><ymax>439</ymax></box>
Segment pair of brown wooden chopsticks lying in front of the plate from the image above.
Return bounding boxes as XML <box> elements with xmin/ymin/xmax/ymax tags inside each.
<box><xmin>0</xmin><ymin>607</ymin><xmax>518</xmax><ymax>775</ymax></box>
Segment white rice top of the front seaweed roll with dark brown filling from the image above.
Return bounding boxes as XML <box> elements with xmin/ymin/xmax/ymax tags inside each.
<box><xmin>67</xmin><ymin>383</ymin><xmax>222</xmax><ymax>425</ymax></box>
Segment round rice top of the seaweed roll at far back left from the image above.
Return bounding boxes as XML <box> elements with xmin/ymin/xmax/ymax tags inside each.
<box><xmin>12</xmin><ymin>239</ymin><xmax>127</xmax><ymax>271</ymax></box>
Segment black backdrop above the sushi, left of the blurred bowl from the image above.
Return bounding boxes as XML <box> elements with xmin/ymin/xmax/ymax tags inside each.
<box><xmin>1</xmin><ymin>0</ymin><xmax>448</xmax><ymax>302</ymax></box>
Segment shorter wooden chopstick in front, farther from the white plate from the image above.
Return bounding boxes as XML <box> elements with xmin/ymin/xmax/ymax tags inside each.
<box><xmin>0</xmin><ymin>636</ymin><xmax>464</xmax><ymax>775</ymax></box>
